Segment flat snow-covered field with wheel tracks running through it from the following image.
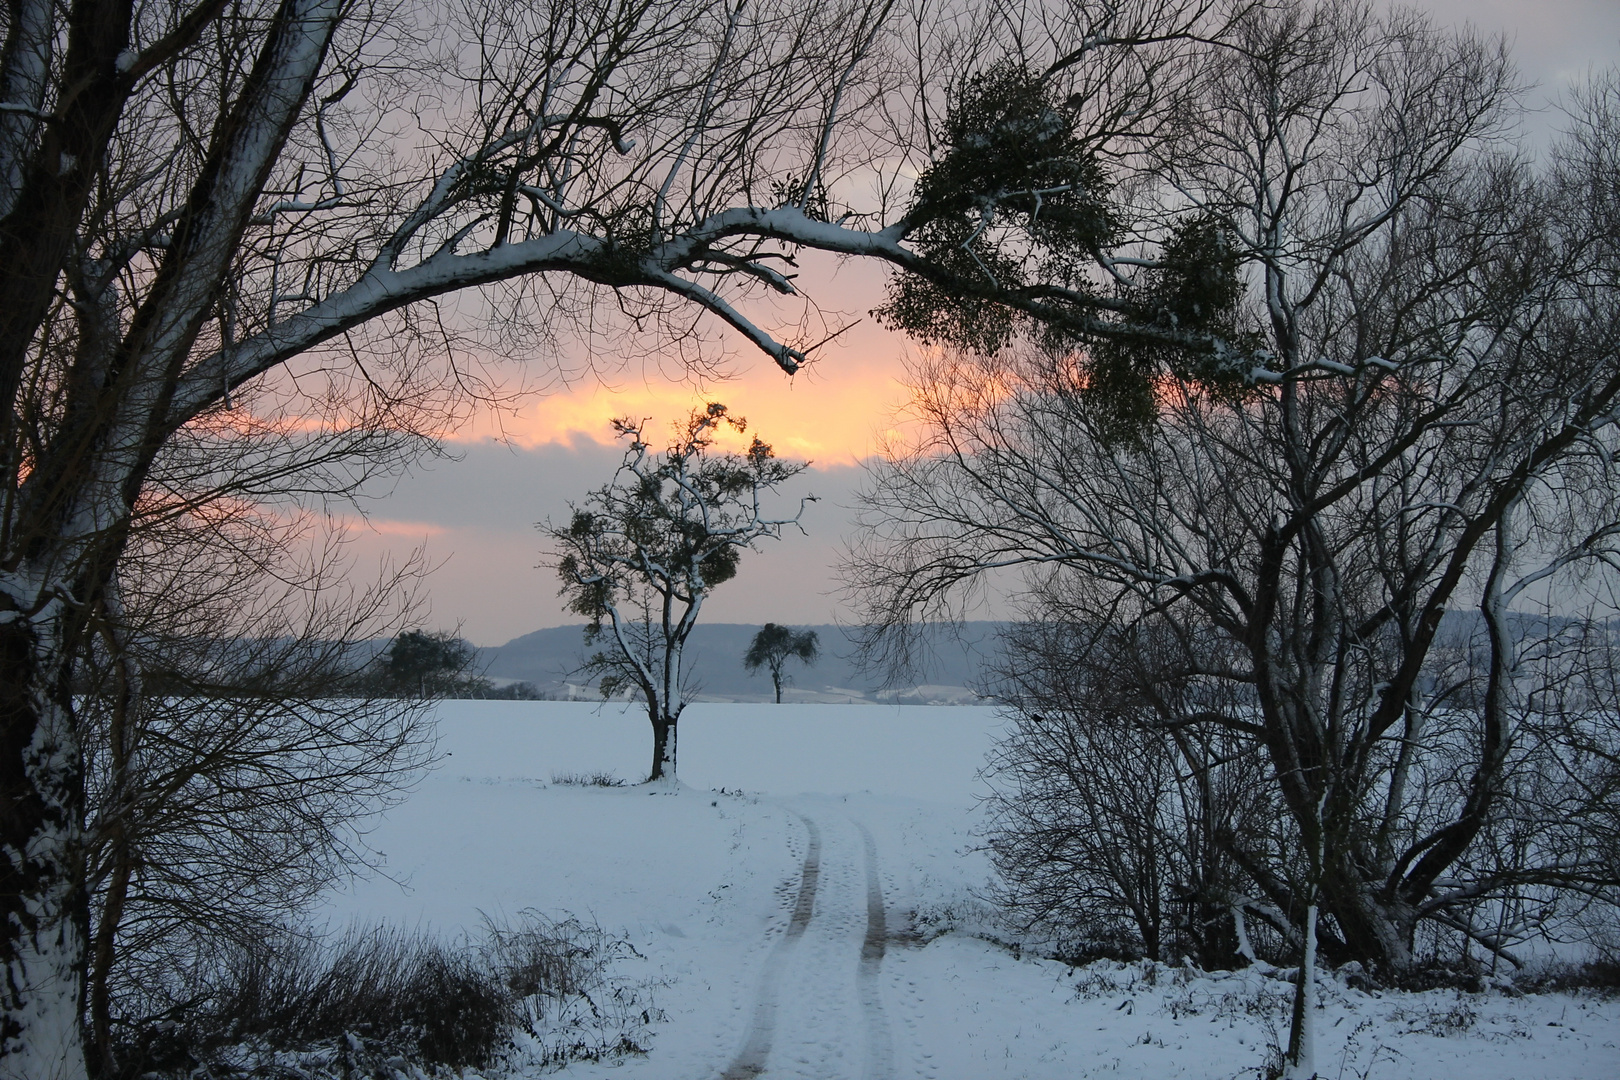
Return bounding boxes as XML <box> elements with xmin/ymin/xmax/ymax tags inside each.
<box><xmin>319</xmin><ymin>701</ymin><xmax>1620</xmax><ymax>1080</ymax></box>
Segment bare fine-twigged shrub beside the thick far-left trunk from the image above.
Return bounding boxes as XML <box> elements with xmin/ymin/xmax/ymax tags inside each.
<box><xmin>75</xmin><ymin>440</ymin><xmax>434</xmax><ymax>1075</ymax></box>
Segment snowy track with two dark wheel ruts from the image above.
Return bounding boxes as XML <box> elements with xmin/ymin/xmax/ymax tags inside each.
<box><xmin>721</xmin><ymin>814</ymin><xmax>894</xmax><ymax>1080</ymax></box>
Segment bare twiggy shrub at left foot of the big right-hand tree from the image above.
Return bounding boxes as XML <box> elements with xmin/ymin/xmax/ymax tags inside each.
<box><xmin>988</xmin><ymin>608</ymin><xmax>1276</xmax><ymax>968</ymax></box>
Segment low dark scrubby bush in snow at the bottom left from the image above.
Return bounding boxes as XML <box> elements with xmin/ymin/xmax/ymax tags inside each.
<box><xmin>107</xmin><ymin>913</ymin><xmax>654</xmax><ymax>1080</ymax></box>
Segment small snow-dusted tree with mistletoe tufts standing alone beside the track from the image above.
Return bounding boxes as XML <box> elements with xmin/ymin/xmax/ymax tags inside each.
<box><xmin>546</xmin><ymin>405</ymin><xmax>813</xmax><ymax>780</ymax></box>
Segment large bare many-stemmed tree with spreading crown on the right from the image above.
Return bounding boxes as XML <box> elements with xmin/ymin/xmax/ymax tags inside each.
<box><xmin>851</xmin><ymin>3</ymin><xmax>1620</xmax><ymax>1075</ymax></box>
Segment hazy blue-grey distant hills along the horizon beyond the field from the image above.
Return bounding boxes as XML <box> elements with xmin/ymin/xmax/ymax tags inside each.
<box><xmin>478</xmin><ymin>622</ymin><xmax>1004</xmax><ymax>704</ymax></box>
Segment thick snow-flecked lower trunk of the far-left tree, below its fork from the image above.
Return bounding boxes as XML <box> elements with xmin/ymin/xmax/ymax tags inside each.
<box><xmin>0</xmin><ymin>589</ymin><xmax>89</xmax><ymax>1080</ymax></box>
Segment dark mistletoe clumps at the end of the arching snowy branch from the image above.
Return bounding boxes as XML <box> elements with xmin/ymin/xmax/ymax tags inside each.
<box><xmin>875</xmin><ymin>63</ymin><xmax>1260</xmax><ymax>444</ymax></box>
